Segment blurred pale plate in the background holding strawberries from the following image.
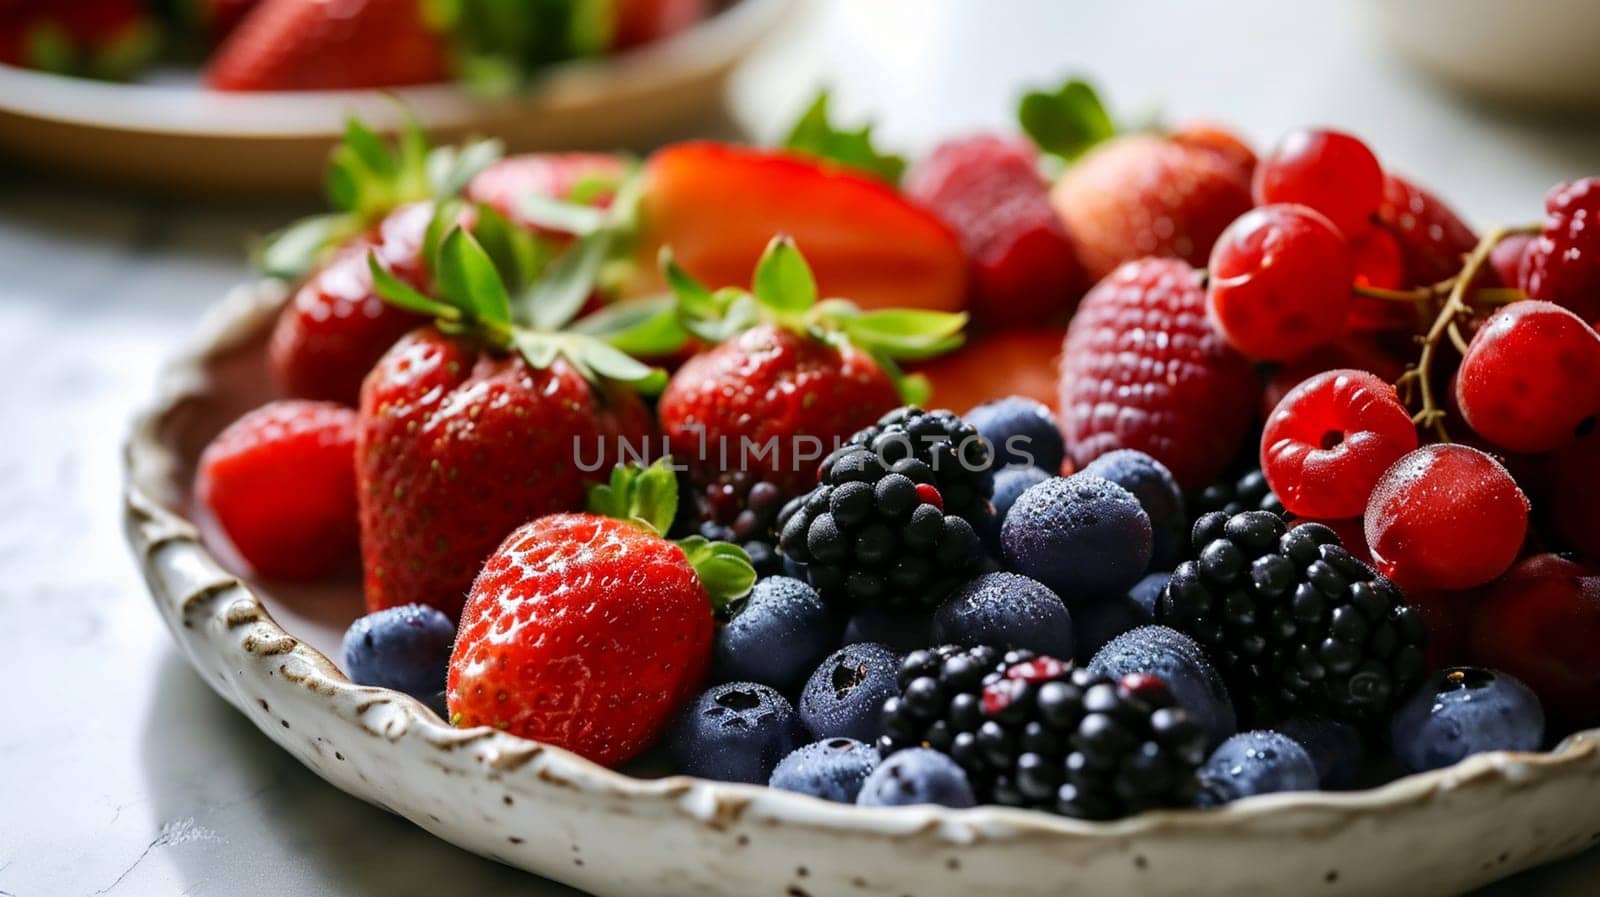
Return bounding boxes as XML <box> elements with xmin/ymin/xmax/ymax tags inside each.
<box><xmin>0</xmin><ymin>0</ymin><xmax>795</xmax><ymax>193</ymax></box>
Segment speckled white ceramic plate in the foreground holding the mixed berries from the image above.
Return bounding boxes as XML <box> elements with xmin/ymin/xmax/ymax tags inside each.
<box><xmin>126</xmin><ymin>285</ymin><xmax>1600</xmax><ymax>897</ymax></box>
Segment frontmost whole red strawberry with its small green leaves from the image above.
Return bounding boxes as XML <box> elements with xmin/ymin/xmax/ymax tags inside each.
<box><xmin>446</xmin><ymin>464</ymin><xmax>755</xmax><ymax>766</ymax></box>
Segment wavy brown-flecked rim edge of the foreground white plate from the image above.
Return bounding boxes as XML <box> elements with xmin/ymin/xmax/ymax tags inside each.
<box><xmin>122</xmin><ymin>280</ymin><xmax>1600</xmax><ymax>847</ymax></box>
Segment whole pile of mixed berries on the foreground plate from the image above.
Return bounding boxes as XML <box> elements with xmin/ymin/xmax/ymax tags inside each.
<box><xmin>184</xmin><ymin>82</ymin><xmax>1600</xmax><ymax>820</ymax></box>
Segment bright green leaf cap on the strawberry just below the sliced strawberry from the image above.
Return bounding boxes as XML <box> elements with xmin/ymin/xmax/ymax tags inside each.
<box><xmin>661</xmin><ymin>235</ymin><xmax>966</xmax><ymax>401</ymax></box>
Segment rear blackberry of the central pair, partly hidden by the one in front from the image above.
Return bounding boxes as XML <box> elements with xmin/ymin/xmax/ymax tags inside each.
<box><xmin>822</xmin><ymin>405</ymin><xmax>995</xmax><ymax>532</ymax></box>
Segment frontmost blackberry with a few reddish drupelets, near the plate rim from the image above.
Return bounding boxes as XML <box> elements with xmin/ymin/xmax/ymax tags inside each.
<box><xmin>878</xmin><ymin>646</ymin><xmax>1205</xmax><ymax>819</ymax></box>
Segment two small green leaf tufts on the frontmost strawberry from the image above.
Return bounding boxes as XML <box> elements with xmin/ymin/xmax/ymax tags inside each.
<box><xmin>587</xmin><ymin>459</ymin><xmax>755</xmax><ymax>611</ymax></box>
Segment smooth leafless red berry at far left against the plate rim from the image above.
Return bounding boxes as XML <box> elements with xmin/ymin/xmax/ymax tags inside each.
<box><xmin>195</xmin><ymin>400</ymin><xmax>357</xmax><ymax>579</ymax></box>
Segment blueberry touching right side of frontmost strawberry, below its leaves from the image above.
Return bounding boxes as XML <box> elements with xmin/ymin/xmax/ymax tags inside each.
<box><xmin>715</xmin><ymin>576</ymin><xmax>837</xmax><ymax>694</ymax></box>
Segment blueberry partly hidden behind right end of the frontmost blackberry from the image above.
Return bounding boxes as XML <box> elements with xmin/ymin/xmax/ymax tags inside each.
<box><xmin>1090</xmin><ymin>627</ymin><xmax>1238</xmax><ymax>747</ymax></box>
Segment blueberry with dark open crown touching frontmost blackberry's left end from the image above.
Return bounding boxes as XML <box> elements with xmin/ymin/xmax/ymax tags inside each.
<box><xmin>800</xmin><ymin>641</ymin><xmax>899</xmax><ymax>744</ymax></box>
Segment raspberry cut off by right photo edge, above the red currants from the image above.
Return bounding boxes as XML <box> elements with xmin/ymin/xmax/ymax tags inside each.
<box><xmin>1518</xmin><ymin>177</ymin><xmax>1600</xmax><ymax>323</ymax></box>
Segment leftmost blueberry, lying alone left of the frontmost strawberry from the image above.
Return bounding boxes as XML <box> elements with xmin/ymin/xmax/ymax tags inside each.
<box><xmin>344</xmin><ymin>604</ymin><xmax>456</xmax><ymax>699</ymax></box>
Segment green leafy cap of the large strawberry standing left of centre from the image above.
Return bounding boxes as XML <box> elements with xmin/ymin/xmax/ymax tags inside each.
<box><xmin>366</xmin><ymin>227</ymin><xmax>667</xmax><ymax>395</ymax></box>
